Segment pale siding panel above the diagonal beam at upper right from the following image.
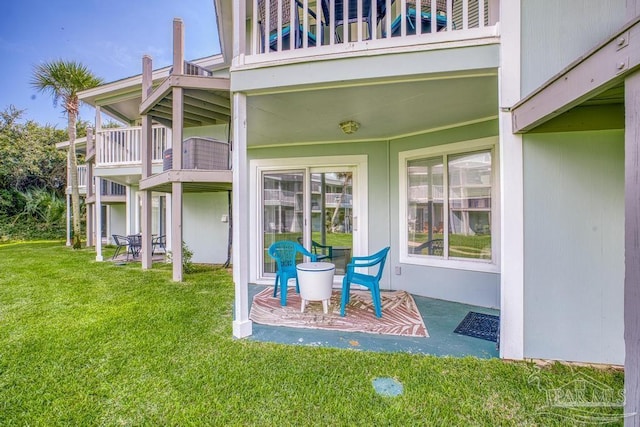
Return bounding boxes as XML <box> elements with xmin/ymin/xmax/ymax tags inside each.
<box><xmin>520</xmin><ymin>0</ymin><xmax>626</xmax><ymax>96</ymax></box>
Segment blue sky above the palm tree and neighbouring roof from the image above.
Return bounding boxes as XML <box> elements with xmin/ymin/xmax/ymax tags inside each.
<box><xmin>0</xmin><ymin>0</ymin><xmax>220</xmax><ymax>129</ymax></box>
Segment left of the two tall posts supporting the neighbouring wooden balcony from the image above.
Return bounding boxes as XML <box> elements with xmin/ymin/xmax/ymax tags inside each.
<box><xmin>140</xmin><ymin>55</ymin><xmax>153</xmax><ymax>270</ymax></box>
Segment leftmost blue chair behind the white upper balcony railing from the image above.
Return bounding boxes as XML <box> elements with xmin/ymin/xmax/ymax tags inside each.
<box><xmin>258</xmin><ymin>0</ymin><xmax>322</xmax><ymax>52</ymax></box>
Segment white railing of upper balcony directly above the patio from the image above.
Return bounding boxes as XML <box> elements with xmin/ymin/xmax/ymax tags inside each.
<box><xmin>246</xmin><ymin>0</ymin><xmax>499</xmax><ymax>56</ymax></box>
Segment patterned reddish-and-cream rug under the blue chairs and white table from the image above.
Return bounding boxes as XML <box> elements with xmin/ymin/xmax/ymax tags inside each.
<box><xmin>249</xmin><ymin>287</ymin><xmax>429</xmax><ymax>337</ymax></box>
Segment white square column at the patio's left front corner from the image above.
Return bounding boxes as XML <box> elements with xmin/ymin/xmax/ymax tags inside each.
<box><xmin>232</xmin><ymin>92</ymin><xmax>252</xmax><ymax>338</ymax></box>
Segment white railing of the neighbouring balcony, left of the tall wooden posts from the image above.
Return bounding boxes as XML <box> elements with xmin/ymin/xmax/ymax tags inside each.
<box><xmin>96</xmin><ymin>126</ymin><xmax>171</xmax><ymax>166</ymax></box>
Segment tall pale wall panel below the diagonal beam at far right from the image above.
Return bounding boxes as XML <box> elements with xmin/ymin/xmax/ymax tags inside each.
<box><xmin>524</xmin><ymin>131</ymin><xmax>624</xmax><ymax>364</ymax></box>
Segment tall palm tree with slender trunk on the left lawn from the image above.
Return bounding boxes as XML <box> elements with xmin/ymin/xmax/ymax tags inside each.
<box><xmin>31</xmin><ymin>60</ymin><xmax>102</xmax><ymax>249</ymax></box>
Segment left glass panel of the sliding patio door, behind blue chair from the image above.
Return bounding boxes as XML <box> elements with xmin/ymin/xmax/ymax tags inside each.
<box><xmin>262</xmin><ymin>171</ymin><xmax>304</xmax><ymax>273</ymax></box>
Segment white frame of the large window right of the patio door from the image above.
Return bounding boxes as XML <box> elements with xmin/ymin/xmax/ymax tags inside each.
<box><xmin>398</xmin><ymin>137</ymin><xmax>500</xmax><ymax>273</ymax></box>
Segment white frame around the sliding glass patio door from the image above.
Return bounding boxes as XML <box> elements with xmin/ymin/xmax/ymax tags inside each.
<box><xmin>249</xmin><ymin>155</ymin><xmax>369</xmax><ymax>285</ymax></box>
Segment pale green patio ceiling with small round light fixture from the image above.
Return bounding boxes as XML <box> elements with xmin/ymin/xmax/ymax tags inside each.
<box><xmin>247</xmin><ymin>70</ymin><xmax>498</xmax><ymax>146</ymax></box>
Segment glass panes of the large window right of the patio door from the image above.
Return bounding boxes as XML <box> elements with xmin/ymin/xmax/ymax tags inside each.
<box><xmin>406</xmin><ymin>149</ymin><xmax>493</xmax><ymax>261</ymax></box>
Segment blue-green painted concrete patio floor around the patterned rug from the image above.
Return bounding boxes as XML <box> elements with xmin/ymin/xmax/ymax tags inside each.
<box><xmin>248</xmin><ymin>285</ymin><xmax>499</xmax><ymax>359</ymax></box>
